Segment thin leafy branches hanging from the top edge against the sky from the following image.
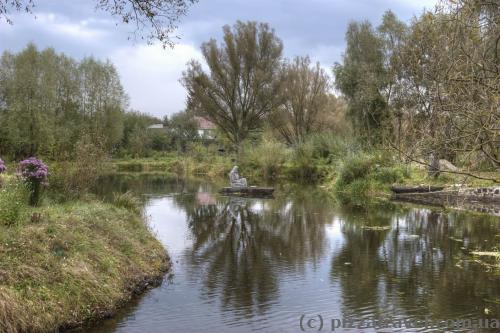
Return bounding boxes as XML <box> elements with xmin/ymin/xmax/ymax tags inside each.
<box><xmin>0</xmin><ymin>0</ymin><xmax>198</xmax><ymax>47</ymax></box>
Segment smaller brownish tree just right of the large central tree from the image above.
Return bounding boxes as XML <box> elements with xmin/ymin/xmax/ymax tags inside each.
<box><xmin>273</xmin><ymin>57</ymin><xmax>330</xmax><ymax>144</ymax></box>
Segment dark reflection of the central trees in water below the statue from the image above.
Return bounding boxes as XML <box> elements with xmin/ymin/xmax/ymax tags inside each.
<box><xmin>175</xmin><ymin>188</ymin><xmax>332</xmax><ymax>316</ymax></box>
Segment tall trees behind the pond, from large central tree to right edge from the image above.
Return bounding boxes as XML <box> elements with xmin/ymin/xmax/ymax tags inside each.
<box><xmin>183</xmin><ymin>0</ymin><xmax>500</xmax><ymax>168</ymax></box>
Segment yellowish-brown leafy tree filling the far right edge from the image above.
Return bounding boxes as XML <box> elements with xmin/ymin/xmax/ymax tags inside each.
<box><xmin>403</xmin><ymin>0</ymin><xmax>500</xmax><ymax>168</ymax></box>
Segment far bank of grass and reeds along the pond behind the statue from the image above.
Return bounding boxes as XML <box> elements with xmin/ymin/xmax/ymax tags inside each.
<box><xmin>111</xmin><ymin>140</ymin><xmax>500</xmax><ymax>199</ymax></box>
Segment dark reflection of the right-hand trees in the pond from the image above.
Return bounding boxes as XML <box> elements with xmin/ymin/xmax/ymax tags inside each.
<box><xmin>331</xmin><ymin>204</ymin><xmax>500</xmax><ymax>318</ymax></box>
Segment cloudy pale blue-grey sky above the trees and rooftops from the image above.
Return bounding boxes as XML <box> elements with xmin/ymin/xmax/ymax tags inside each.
<box><xmin>0</xmin><ymin>0</ymin><xmax>436</xmax><ymax>118</ymax></box>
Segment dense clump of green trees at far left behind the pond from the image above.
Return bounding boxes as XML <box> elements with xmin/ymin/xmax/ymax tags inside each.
<box><xmin>0</xmin><ymin>44</ymin><xmax>127</xmax><ymax>160</ymax></box>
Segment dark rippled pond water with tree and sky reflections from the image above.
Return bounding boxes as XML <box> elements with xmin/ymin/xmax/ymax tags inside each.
<box><xmin>80</xmin><ymin>175</ymin><xmax>500</xmax><ymax>333</ymax></box>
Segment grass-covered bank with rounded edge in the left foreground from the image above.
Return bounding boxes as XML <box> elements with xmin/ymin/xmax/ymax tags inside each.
<box><xmin>0</xmin><ymin>184</ymin><xmax>169</xmax><ymax>333</ymax></box>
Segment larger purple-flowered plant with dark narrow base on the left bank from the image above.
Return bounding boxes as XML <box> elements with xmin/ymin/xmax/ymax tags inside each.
<box><xmin>18</xmin><ymin>157</ymin><xmax>49</xmax><ymax>206</ymax></box>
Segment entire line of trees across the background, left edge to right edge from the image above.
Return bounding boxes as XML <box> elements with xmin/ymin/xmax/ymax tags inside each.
<box><xmin>0</xmin><ymin>0</ymin><xmax>500</xmax><ymax>169</ymax></box>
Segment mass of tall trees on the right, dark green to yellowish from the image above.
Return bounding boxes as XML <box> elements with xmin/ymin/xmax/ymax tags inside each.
<box><xmin>334</xmin><ymin>0</ymin><xmax>500</xmax><ymax>174</ymax></box>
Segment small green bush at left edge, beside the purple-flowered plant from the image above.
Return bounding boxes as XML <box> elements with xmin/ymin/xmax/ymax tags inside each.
<box><xmin>0</xmin><ymin>181</ymin><xmax>27</xmax><ymax>225</ymax></box>
